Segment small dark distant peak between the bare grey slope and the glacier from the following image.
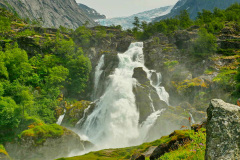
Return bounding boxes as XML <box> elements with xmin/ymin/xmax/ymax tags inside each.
<box><xmin>78</xmin><ymin>3</ymin><xmax>106</xmax><ymax>20</ymax></box>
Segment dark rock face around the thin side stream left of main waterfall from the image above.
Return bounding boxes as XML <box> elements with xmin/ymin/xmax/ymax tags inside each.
<box><xmin>82</xmin><ymin>27</ymin><xmax>134</xmax><ymax>101</ymax></box>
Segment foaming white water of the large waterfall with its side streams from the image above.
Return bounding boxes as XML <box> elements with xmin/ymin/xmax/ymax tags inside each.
<box><xmin>79</xmin><ymin>42</ymin><xmax>169</xmax><ymax>149</ymax></box>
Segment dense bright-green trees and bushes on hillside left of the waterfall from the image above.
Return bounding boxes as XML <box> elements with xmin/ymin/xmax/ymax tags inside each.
<box><xmin>0</xmin><ymin>9</ymin><xmax>91</xmax><ymax>143</ymax></box>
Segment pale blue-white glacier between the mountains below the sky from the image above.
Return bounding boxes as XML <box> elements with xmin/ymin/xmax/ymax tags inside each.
<box><xmin>98</xmin><ymin>6</ymin><xmax>173</xmax><ymax>29</ymax></box>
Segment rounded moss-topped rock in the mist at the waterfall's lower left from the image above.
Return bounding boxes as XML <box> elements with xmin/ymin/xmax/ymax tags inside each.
<box><xmin>5</xmin><ymin>124</ymin><xmax>85</xmax><ymax>160</ymax></box>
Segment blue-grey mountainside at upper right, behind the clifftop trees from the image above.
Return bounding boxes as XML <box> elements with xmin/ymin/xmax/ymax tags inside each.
<box><xmin>153</xmin><ymin>0</ymin><xmax>240</xmax><ymax>22</ymax></box>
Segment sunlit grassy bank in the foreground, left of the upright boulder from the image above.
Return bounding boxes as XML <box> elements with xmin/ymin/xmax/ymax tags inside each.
<box><xmin>58</xmin><ymin>129</ymin><xmax>206</xmax><ymax>160</ymax></box>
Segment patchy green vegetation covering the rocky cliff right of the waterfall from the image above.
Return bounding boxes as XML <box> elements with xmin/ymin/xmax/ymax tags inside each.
<box><xmin>133</xmin><ymin>3</ymin><xmax>240</xmax><ymax>106</ymax></box>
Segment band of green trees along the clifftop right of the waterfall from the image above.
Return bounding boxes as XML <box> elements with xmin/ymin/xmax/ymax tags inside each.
<box><xmin>129</xmin><ymin>3</ymin><xmax>240</xmax><ymax>40</ymax></box>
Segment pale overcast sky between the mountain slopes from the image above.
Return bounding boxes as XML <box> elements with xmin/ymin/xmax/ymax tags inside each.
<box><xmin>76</xmin><ymin>0</ymin><xmax>178</xmax><ymax>18</ymax></box>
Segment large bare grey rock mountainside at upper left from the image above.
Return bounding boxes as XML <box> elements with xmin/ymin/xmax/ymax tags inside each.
<box><xmin>0</xmin><ymin>0</ymin><xmax>95</xmax><ymax>29</ymax></box>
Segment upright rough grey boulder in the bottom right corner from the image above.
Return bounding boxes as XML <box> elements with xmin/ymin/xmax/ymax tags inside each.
<box><xmin>205</xmin><ymin>99</ymin><xmax>240</xmax><ymax>160</ymax></box>
